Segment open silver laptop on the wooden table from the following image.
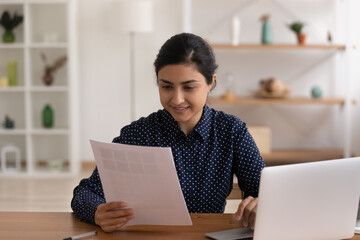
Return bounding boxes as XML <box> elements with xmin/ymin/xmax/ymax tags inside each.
<box><xmin>206</xmin><ymin>157</ymin><xmax>360</xmax><ymax>240</ymax></box>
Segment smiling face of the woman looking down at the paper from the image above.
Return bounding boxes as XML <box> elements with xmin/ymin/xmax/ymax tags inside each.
<box><xmin>158</xmin><ymin>64</ymin><xmax>216</xmax><ymax>135</ymax></box>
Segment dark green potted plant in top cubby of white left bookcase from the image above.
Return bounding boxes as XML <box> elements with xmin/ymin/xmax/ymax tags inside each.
<box><xmin>0</xmin><ymin>11</ymin><xmax>23</xmax><ymax>43</ymax></box>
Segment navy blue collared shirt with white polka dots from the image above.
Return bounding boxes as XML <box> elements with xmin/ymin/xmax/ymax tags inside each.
<box><xmin>71</xmin><ymin>105</ymin><xmax>265</xmax><ymax>223</ymax></box>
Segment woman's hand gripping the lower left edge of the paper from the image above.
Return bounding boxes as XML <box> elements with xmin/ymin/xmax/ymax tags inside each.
<box><xmin>95</xmin><ymin>202</ymin><xmax>135</xmax><ymax>232</ymax></box>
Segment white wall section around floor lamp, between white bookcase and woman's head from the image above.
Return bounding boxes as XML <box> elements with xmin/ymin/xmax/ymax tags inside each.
<box><xmin>78</xmin><ymin>0</ymin><xmax>181</xmax><ymax>160</ymax></box>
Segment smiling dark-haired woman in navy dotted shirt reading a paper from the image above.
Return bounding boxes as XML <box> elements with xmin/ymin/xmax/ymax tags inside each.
<box><xmin>71</xmin><ymin>33</ymin><xmax>265</xmax><ymax>232</ymax></box>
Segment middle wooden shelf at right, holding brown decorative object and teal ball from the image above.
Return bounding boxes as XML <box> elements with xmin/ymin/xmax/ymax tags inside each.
<box><xmin>208</xmin><ymin>97</ymin><xmax>356</xmax><ymax>105</ymax></box>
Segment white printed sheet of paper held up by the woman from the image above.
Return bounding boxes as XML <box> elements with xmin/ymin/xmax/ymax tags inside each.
<box><xmin>90</xmin><ymin>140</ymin><xmax>192</xmax><ymax>226</ymax></box>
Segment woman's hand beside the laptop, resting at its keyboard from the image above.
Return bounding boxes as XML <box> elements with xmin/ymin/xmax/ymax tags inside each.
<box><xmin>235</xmin><ymin>196</ymin><xmax>258</xmax><ymax>229</ymax></box>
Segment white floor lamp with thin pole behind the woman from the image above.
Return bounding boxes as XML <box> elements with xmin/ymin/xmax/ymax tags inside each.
<box><xmin>113</xmin><ymin>0</ymin><xmax>153</xmax><ymax>121</ymax></box>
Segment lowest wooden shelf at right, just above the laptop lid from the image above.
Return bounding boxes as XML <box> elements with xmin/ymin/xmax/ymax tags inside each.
<box><xmin>262</xmin><ymin>149</ymin><xmax>344</xmax><ymax>166</ymax></box>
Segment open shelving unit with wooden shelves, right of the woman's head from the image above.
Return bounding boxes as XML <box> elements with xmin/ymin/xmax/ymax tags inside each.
<box><xmin>183</xmin><ymin>0</ymin><xmax>355</xmax><ymax>165</ymax></box>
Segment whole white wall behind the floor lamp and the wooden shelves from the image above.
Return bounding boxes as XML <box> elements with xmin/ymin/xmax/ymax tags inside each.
<box><xmin>78</xmin><ymin>0</ymin><xmax>360</xmax><ymax>160</ymax></box>
